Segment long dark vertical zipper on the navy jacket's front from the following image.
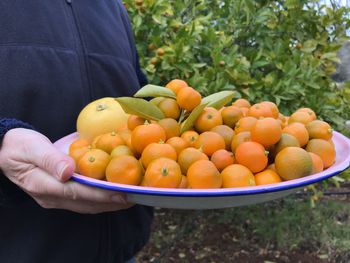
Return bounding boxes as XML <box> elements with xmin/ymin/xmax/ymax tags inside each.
<box><xmin>65</xmin><ymin>0</ymin><xmax>93</xmax><ymax>103</ymax></box>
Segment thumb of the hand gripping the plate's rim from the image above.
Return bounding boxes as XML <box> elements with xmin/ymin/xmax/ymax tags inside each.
<box><xmin>31</xmin><ymin>141</ymin><xmax>75</xmax><ymax>182</ymax></box>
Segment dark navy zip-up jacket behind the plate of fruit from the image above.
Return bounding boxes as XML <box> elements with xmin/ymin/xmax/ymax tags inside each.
<box><xmin>0</xmin><ymin>0</ymin><xmax>152</xmax><ymax>263</ymax></box>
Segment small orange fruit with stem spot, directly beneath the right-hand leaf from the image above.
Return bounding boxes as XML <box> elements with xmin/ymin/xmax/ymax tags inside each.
<box><xmin>194</xmin><ymin>107</ymin><xmax>222</xmax><ymax>133</ymax></box>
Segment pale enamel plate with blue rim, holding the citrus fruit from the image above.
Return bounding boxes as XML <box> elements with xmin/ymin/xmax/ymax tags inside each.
<box><xmin>54</xmin><ymin>132</ymin><xmax>350</xmax><ymax>209</ymax></box>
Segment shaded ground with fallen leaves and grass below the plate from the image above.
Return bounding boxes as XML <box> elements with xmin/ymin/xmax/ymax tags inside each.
<box><xmin>136</xmin><ymin>184</ymin><xmax>350</xmax><ymax>263</ymax></box>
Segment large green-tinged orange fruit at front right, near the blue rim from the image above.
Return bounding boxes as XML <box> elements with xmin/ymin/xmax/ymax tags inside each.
<box><xmin>275</xmin><ymin>147</ymin><xmax>313</xmax><ymax>180</ymax></box>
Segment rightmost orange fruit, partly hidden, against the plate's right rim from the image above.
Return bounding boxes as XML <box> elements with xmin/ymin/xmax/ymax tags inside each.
<box><xmin>305</xmin><ymin>139</ymin><xmax>336</xmax><ymax>169</ymax></box>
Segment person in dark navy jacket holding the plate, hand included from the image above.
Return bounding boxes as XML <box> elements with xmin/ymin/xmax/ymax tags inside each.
<box><xmin>0</xmin><ymin>0</ymin><xmax>153</xmax><ymax>263</ymax></box>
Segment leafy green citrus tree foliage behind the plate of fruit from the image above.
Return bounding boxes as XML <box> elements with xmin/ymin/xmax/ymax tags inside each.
<box><xmin>124</xmin><ymin>0</ymin><xmax>350</xmax><ymax>135</ymax></box>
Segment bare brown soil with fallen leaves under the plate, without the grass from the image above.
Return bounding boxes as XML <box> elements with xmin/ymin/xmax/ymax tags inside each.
<box><xmin>136</xmin><ymin>185</ymin><xmax>350</xmax><ymax>263</ymax></box>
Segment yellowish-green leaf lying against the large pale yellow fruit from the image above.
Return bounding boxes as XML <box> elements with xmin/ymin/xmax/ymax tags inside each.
<box><xmin>115</xmin><ymin>97</ymin><xmax>165</xmax><ymax>121</ymax></box>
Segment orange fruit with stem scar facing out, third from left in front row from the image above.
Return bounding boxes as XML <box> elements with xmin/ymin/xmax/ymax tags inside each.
<box><xmin>144</xmin><ymin>158</ymin><xmax>182</xmax><ymax>188</ymax></box>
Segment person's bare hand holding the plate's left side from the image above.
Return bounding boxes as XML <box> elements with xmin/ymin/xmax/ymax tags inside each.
<box><xmin>0</xmin><ymin>128</ymin><xmax>130</xmax><ymax>214</ymax></box>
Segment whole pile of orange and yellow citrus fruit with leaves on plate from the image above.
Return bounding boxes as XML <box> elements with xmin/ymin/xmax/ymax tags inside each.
<box><xmin>69</xmin><ymin>79</ymin><xmax>336</xmax><ymax>189</ymax></box>
